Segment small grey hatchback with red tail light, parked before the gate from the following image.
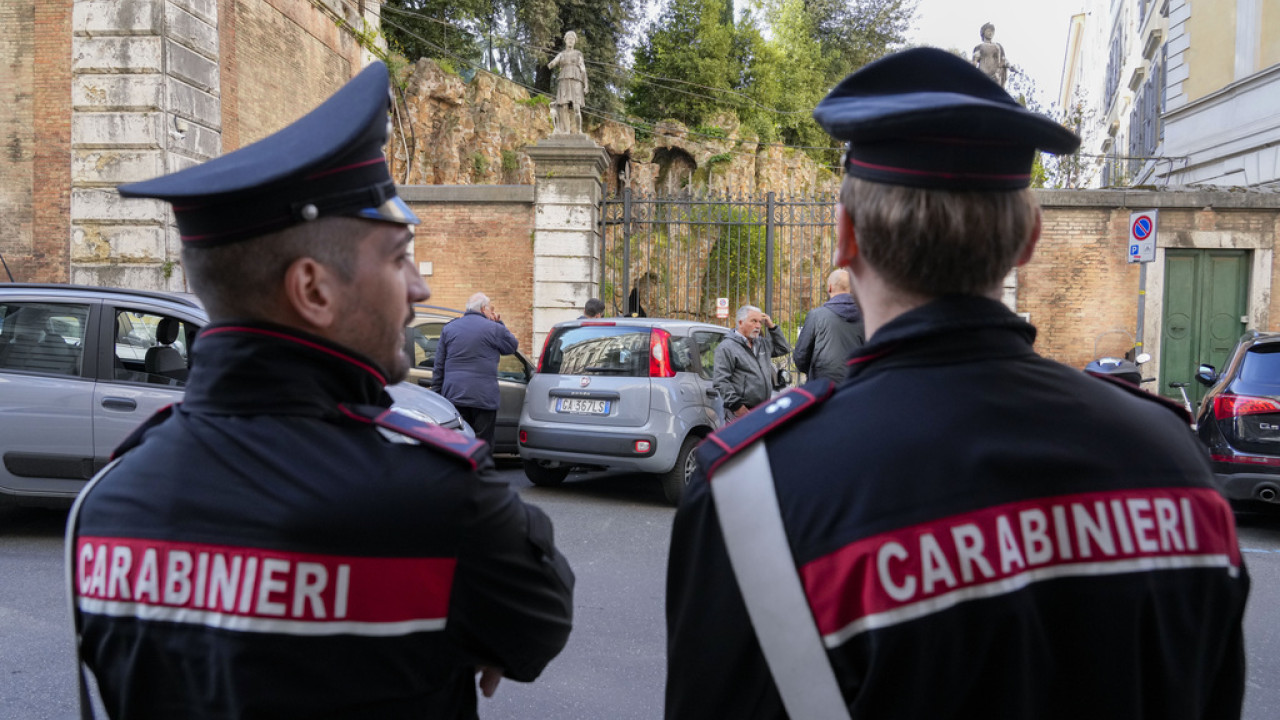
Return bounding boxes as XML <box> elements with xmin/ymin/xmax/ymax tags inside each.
<box><xmin>520</xmin><ymin>318</ymin><xmax>728</xmax><ymax>503</ymax></box>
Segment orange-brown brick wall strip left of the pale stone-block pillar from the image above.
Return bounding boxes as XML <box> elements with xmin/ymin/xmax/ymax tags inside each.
<box><xmin>0</xmin><ymin>0</ymin><xmax>72</xmax><ymax>282</ymax></box>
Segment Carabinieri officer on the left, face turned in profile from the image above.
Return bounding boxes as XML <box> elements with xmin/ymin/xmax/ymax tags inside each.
<box><xmin>68</xmin><ymin>63</ymin><xmax>573</xmax><ymax>720</ymax></box>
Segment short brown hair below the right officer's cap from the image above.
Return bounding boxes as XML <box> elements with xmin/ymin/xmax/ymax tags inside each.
<box><xmin>840</xmin><ymin>176</ymin><xmax>1038</xmax><ymax>296</ymax></box>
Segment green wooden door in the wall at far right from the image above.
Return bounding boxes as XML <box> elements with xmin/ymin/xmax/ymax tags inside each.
<box><xmin>1160</xmin><ymin>250</ymin><xmax>1249</xmax><ymax>402</ymax></box>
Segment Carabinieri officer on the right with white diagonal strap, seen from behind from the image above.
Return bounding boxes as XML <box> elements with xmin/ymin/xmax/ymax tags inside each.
<box><xmin>666</xmin><ymin>47</ymin><xmax>1249</xmax><ymax>720</ymax></box>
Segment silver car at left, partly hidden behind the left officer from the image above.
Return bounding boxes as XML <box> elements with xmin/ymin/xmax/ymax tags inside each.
<box><xmin>0</xmin><ymin>283</ymin><xmax>475</xmax><ymax>505</ymax></box>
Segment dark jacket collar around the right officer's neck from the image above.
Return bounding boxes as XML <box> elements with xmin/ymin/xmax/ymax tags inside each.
<box><xmin>847</xmin><ymin>295</ymin><xmax>1036</xmax><ymax>375</ymax></box>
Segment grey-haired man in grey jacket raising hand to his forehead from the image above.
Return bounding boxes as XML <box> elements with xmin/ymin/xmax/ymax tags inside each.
<box><xmin>714</xmin><ymin>305</ymin><xmax>791</xmax><ymax>421</ymax></box>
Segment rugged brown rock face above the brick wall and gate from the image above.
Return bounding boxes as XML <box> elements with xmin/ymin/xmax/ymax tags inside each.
<box><xmin>389</xmin><ymin>59</ymin><xmax>840</xmax><ymax>195</ymax></box>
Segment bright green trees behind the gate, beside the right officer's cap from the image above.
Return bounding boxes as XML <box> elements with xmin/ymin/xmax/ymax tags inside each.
<box><xmin>627</xmin><ymin>0</ymin><xmax>918</xmax><ymax>160</ymax></box>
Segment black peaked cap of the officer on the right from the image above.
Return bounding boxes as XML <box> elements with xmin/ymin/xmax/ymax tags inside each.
<box><xmin>813</xmin><ymin>47</ymin><xmax>1080</xmax><ymax>191</ymax></box>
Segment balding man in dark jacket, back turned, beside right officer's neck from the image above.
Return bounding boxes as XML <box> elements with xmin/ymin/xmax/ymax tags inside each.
<box><xmin>791</xmin><ymin>268</ymin><xmax>864</xmax><ymax>383</ymax></box>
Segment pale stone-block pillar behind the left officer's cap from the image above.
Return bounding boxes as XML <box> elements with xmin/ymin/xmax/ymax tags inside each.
<box><xmin>70</xmin><ymin>0</ymin><xmax>221</xmax><ymax>290</ymax></box>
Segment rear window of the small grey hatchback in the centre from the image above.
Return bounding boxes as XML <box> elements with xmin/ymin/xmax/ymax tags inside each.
<box><xmin>541</xmin><ymin>325</ymin><xmax>649</xmax><ymax>378</ymax></box>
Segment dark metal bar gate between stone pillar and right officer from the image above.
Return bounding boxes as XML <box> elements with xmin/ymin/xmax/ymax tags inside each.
<box><xmin>600</xmin><ymin>190</ymin><xmax>836</xmax><ymax>371</ymax></box>
